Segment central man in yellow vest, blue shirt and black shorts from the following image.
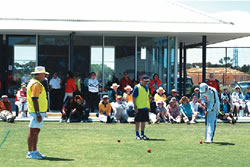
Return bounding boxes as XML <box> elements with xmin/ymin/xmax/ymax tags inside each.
<box><xmin>133</xmin><ymin>75</ymin><xmax>150</xmax><ymax>140</ymax></box>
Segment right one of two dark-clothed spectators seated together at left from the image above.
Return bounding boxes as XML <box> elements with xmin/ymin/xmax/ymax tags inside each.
<box><xmin>71</xmin><ymin>95</ymin><xmax>89</xmax><ymax>122</ymax></box>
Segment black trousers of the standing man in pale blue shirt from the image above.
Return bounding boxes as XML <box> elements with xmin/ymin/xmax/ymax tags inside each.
<box><xmin>50</xmin><ymin>89</ymin><xmax>61</xmax><ymax>110</ymax></box>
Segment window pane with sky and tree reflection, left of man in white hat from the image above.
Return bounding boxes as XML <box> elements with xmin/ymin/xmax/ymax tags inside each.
<box><xmin>7</xmin><ymin>36</ymin><xmax>37</xmax><ymax>97</ymax></box>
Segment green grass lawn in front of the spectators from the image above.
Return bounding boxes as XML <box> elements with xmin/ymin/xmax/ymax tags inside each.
<box><xmin>0</xmin><ymin>122</ymin><xmax>250</xmax><ymax>167</ymax></box>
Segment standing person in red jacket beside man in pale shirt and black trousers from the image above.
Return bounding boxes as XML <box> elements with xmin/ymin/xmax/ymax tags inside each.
<box><xmin>63</xmin><ymin>71</ymin><xmax>76</xmax><ymax>102</ymax></box>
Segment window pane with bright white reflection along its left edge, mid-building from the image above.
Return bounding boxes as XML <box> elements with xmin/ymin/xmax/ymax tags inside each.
<box><xmin>104</xmin><ymin>37</ymin><xmax>135</xmax><ymax>90</ymax></box>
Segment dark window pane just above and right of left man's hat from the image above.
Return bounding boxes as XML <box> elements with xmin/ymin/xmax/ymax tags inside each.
<box><xmin>38</xmin><ymin>36</ymin><xmax>69</xmax><ymax>77</ymax></box>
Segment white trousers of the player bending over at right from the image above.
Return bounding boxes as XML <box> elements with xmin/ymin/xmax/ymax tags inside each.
<box><xmin>205</xmin><ymin>110</ymin><xmax>218</xmax><ymax>142</ymax></box>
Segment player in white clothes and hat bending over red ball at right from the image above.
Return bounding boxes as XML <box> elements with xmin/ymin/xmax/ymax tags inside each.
<box><xmin>200</xmin><ymin>83</ymin><xmax>220</xmax><ymax>143</ymax></box>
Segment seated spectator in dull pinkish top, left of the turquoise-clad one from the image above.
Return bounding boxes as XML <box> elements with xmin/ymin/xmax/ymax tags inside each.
<box><xmin>166</xmin><ymin>97</ymin><xmax>181</xmax><ymax>123</ymax></box>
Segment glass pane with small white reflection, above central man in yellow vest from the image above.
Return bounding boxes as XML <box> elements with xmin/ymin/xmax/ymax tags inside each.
<box><xmin>137</xmin><ymin>37</ymin><xmax>168</xmax><ymax>90</ymax></box>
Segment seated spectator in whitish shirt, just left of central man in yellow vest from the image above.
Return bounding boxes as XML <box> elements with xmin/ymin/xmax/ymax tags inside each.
<box><xmin>112</xmin><ymin>95</ymin><xmax>129</xmax><ymax>123</ymax></box>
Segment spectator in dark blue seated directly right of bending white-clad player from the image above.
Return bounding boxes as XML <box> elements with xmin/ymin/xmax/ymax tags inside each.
<box><xmin>218</xmin><ymin>96</ymin><xmax>236</xmax><ymax>124</ymax></box>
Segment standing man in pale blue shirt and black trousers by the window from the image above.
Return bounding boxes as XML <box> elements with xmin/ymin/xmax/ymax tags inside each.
<box><xmin>49</xmin><ymin>73</ymin><xmax>61</xmax><ymax>110</ymax></box>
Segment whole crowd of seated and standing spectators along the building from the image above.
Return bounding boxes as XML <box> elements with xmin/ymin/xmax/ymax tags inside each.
<box><xmin>0</xmin><ymin>72</ymin><xmax>250</xmax><ymax>124</ymax></box>
